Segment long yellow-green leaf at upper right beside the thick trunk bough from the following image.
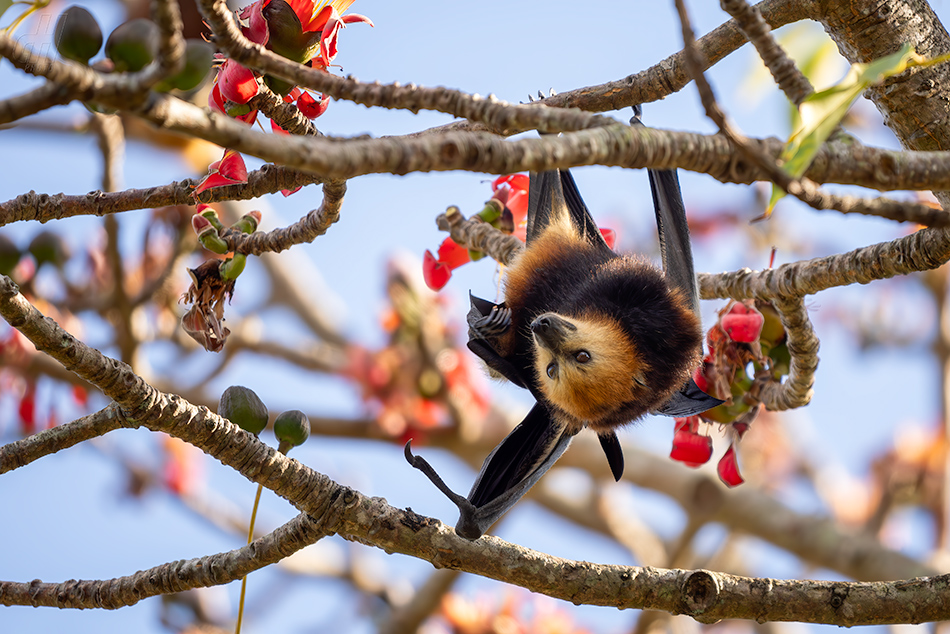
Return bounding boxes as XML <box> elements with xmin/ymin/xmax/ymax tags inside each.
<box><xmin>765</xmin><ymin>44</ymin><xmax>932</xmax><ymax>217</ymax></box>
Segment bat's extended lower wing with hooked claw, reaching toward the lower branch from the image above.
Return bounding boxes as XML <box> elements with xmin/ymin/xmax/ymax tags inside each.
<box><xmin>406</xmin><ymin>403</ymin><xmax>573</xmax><ymax>539</ymax></box>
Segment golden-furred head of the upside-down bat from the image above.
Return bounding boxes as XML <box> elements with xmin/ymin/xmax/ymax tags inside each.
<box><xmin>531</xmin><ymin>313</ymin><xmax>650</xmax><ymax>424</ymax></box>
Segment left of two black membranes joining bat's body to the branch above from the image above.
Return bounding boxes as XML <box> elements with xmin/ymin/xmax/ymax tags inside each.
<box><xmin>527</xmin><ymin>170</ymin><xmax>610</xmax><ymax>251</ymax></box>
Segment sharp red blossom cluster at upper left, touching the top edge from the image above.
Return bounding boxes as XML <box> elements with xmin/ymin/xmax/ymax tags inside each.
<box><xmin>194</xmin><ymin>0</ymin><xmax>373</xmax><ymax>197</ymax></box>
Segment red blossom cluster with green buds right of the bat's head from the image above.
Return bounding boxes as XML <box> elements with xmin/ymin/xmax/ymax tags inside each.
<box><xmin>670</xmin><ymin>300</ymin><xmax>791</xmax><ymax>487</ymax></box>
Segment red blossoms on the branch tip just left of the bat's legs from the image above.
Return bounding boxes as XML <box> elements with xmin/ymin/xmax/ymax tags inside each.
<box><xmin>422</xmin><ymin>174</ymin><xmax>617</xmax><ymax>291</ymax></box>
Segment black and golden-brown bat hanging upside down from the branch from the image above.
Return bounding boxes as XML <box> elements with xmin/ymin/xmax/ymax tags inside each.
<box><xmin>405</xmin><ymin>115</ymin><xmax>722</xmax><ymax>539</ymax></box>
